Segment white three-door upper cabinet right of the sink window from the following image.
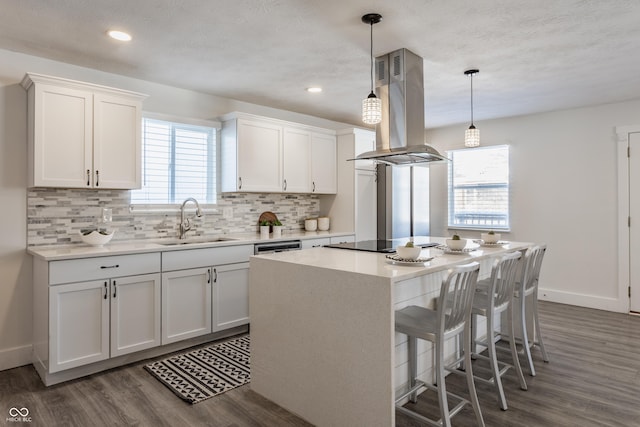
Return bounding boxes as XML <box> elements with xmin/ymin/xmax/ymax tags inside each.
<box><xmin>221</xmin><ymin>113</ymin><xmax>336</xmax><ymax>193</ymax></box>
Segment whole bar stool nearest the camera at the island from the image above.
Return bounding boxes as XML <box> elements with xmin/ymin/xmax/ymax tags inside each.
<box><xmin>395</xmin><ymin>262</ymin><xmax>484</xmax><ymax>426</ymax></box>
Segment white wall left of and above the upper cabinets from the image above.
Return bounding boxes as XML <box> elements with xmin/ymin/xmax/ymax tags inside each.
<box><xmin>0</xmin><ymin>50</ymin><xmax>349</xmax><ymax>370</ymax></box>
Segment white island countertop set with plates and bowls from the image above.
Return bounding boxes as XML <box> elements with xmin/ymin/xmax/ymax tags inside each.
<box><xmin>252</xmin><ymin>237</ymin><xmax>533</xmax><ymax>282</ymax></box>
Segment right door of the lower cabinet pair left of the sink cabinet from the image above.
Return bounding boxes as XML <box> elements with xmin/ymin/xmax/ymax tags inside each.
<box><xmin>111</xmin><ymin>274</ymin><xmax>160</xmax><ymax>357</ymax></box>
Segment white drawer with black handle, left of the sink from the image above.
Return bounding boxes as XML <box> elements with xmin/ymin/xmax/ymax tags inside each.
<box><xmin>49</xmin><ymin>252</ymin><xmax>160</xmax><ymax>285</ymax></box>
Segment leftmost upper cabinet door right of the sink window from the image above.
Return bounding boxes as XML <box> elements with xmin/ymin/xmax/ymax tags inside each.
<box><xmin>237</xmin><ymin>119</ymin><xmax>282</xmax><ymax>192</ymax></box>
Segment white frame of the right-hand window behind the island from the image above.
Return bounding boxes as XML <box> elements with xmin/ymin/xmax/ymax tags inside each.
<box><xmin>447</xmin><ymin>144</ymin><xmax>513</xmax><ymax>232</ymax></box>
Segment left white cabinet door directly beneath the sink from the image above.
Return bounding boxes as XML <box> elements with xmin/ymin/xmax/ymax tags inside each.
<box><xmin>162</xmin><ymin>268</ymin><xmax>211</xmax><ymax>344</ymax></box>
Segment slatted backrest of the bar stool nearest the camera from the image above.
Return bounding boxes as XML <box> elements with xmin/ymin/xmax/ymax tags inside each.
<box><xmin>438</xmin><ymin>262</ymin><xmax>480</xmax><ymax>339</ymax></box>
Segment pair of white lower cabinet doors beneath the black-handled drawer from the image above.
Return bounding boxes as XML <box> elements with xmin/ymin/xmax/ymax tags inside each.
<box><xmin>49</xmin><ymin>274</ymin><xmax>160</xmax><ymax>372</ymax></box>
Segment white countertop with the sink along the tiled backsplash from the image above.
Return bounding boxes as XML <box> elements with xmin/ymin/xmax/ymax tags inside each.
<box><xmin>27</xmin><ymin>230</ymin><xmax>354</xmax><ymax>261</ymax></box>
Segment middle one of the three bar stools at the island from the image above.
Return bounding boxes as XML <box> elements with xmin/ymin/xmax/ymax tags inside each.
<box><xmin>471</xmin><ymin>251</ymin><xmax>527</xmax><ymax>411</ymax></box>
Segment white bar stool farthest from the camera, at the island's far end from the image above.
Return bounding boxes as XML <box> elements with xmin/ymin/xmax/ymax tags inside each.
<box><xmin>514</xmin><ymin>245</ymin><xmax>549</xmax><ymax>377</ymax></box>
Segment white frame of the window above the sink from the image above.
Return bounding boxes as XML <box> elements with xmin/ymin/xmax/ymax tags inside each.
<box><xmin>129</xmin><ymin>111</ymin><xmax>222</xmax><ymax>208</ymax></box>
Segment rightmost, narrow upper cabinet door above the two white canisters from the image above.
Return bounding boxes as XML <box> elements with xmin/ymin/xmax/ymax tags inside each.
<box><xmin>311</xmin><ymin>133</ymin><xmax>338</xmax><ymax>194</ymax></box>
